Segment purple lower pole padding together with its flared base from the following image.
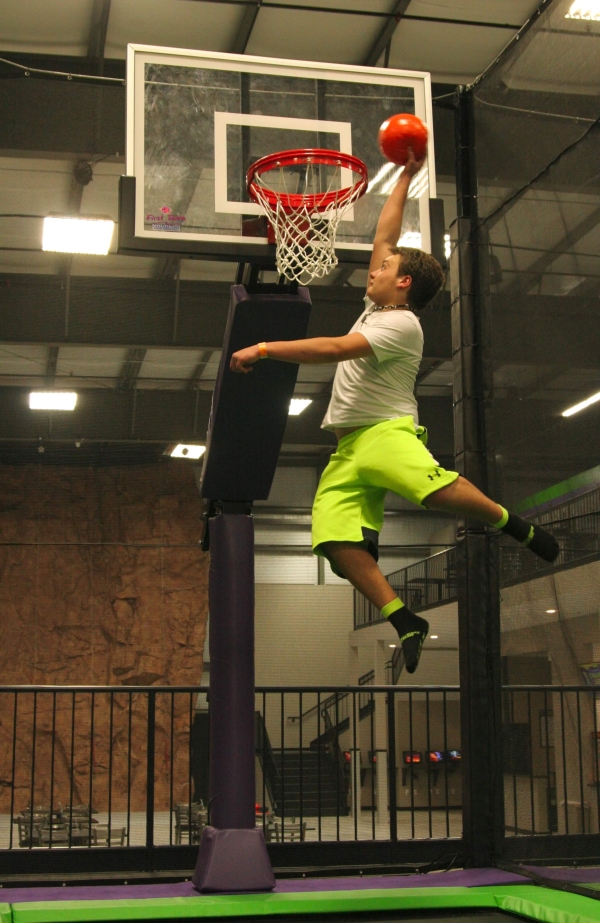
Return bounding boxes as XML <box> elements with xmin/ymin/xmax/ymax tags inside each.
<box><xmin>192</xmin><ymin>513</ymin><xmax>275</xmax><ymax>892</ymax></box>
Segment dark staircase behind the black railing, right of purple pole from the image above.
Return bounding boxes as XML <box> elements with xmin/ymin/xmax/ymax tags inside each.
<box><xmin>273</xmin><ymin>745</ymin><xmax>349</xmax><ymax>817</ymax></box>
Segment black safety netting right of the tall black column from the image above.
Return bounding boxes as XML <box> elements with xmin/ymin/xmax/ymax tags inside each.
<box><xmin>474</xmin><ymin>0</ymin><xmax>600</xmax><ymax>862</ymax></box>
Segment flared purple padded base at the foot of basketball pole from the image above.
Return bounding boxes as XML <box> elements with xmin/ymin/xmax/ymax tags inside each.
<box><xmin>192</xmin><ymin>827</ymin><xmax>275</xmax><ymax>893</ymax></box>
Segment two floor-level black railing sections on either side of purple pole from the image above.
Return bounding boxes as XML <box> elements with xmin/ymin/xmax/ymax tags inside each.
<box><xmin>0</xmin><ymin>676</ymin><xmax>461</xmax><ymax>871</ymax></box>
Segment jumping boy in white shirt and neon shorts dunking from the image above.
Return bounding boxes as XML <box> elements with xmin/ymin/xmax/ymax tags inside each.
<box><xmin>230</xmin><ymin>152</ymin><xmax>559</xmax><ymax>673</ymax></box>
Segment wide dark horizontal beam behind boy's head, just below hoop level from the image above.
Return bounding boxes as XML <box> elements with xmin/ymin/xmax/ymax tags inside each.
<box><xmin>0</xmin><ymin>274</ymin><xmax>452</xmax><ymax>359</ymax></box>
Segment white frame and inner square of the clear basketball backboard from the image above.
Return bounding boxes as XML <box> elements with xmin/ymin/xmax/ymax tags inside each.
<box><xmin>119</xmin><ymin>44</ymin><xmax>436</xmax><ymax>265</ymax></box>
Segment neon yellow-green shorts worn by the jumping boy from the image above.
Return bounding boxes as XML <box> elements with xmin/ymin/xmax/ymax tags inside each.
<box><xmin>312</xmin><ymin>416</ymin><xmax>458</xmax><ymax>576</ymax></box>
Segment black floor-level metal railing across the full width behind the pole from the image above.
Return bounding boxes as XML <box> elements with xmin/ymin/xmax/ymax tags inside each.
<box><xmin>0</xmin><ymin>682</ymin><xmax>600</xmax><ymax>872</ymax></box>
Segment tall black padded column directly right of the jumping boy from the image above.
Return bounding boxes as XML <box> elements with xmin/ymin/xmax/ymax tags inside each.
<box><xmin>450</xmin><ymin>88</ymin><xmax>504</xmax><ymax>867</ymax></box>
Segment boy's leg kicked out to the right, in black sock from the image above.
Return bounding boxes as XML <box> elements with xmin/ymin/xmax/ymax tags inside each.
<box><xmin>423</xmin><ymin>476</ymin><xmax>560</xmax><ymax>563</ymax></box>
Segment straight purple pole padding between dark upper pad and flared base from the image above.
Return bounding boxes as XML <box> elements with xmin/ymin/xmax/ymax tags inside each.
<box><xmin>208</xmin><ymin>513</ymin><xmax>256</xmax><ymax>830</ymax></box>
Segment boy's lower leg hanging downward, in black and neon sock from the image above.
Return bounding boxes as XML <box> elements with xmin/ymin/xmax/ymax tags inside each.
<box><xmin>323</xmin><ymin>542</ymin><xmax>429</xmax><ymax>673</ymax></box>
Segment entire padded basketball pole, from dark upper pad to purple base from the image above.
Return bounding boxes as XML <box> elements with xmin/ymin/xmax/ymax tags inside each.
<box><xmin>192</xmin><ymin>286</ymin><xmax>310</xmax><ymax>892</ymax></box>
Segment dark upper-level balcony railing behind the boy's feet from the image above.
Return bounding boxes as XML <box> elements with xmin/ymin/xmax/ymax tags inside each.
<box><xmin>354</xmin><ymin>512</ymin><xmax>600</xmax><ymax>628</ymax></box>
